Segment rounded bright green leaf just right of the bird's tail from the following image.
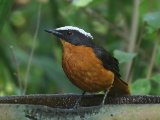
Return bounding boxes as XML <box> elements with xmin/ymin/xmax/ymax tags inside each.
<box><xmin>131</xmin><ymin>79</ymin><xmax>151</xmax><ymax>95</ymax></box>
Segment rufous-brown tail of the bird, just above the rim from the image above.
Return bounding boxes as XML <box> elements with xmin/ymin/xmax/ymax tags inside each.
<box><xmin>108</xmin><ymin>78</ymin><xmax>131</xmax><ymax>96</ymax></box>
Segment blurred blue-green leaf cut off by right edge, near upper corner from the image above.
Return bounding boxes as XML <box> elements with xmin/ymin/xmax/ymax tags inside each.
<box><xmin>143</xmin><ymin>11</ymin><xmax>160</xmax><ymax>30</ymax></box>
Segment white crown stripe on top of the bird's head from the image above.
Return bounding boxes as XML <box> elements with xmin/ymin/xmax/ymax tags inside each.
<box><xmin>56</xmin><ymin>26</ymin><xmax>93</xmax><ymax>39</ymax></box>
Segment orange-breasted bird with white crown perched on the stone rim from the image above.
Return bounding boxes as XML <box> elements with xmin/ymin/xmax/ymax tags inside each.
<box><xmin>45</xmin><ymin>26</ymin><xmax>131</xmax><ymax>106</ymax></box>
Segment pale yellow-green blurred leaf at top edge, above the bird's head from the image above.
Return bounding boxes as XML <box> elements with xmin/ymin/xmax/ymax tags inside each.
<box><xmin>72</xmin><ymin>0</ymin><xmax>93</xmax><ymax>7</ymax></box>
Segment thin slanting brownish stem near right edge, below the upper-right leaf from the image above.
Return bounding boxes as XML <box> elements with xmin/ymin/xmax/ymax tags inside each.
<box><xmin>146</xmin><ymin>35</ymin><xmax>159</xmax><ymax>80</ymax></box>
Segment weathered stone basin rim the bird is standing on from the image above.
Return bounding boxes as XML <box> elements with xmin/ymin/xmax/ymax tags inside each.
<box><xmin>0</xmin><ymin>94</ymin><xmax>160</xmax><ymax>120</ymax></box>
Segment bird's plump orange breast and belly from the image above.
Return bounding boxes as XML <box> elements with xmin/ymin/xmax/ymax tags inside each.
<box><xmin>62</xmin><ymin>41</ymin><xmax>114</xmax><ymax>92</ymax></box>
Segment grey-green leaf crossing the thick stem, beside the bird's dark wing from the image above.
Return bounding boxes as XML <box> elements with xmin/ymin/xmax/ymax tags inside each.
<box><xmin>114</xmin><ymin>50</ymin><xmax>136</xmax><ymax>63</ymax></box>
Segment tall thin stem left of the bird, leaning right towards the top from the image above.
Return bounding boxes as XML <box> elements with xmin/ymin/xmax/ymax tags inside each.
<box><xmin>23</xmin><ymin>3</ymin><xmax>41</xmax><ymax>94</ymax></box>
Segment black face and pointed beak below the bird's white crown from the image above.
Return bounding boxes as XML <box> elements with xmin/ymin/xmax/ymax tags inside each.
<box><xmin>45</xmin><ymin>29</ymin><xmax>93</xmax><ymax>46</ymax></box>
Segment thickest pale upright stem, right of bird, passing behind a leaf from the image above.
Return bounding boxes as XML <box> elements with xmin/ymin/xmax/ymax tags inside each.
<box><xmin>125</xmin><ymin>0</ymin><xmax>140</xmax><ymax>82</ymax></box>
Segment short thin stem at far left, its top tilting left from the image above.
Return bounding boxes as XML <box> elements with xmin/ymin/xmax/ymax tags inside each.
<box><xmin>9</xmin><ymin>45</ymin><xmax>22</xmax><ymax>95</ymax></box>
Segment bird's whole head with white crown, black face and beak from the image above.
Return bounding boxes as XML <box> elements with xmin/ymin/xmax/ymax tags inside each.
<box><xmin>45</xmin><ymin>26</ymin><xmax>93</xmax><ymax>46</ymax></box>
